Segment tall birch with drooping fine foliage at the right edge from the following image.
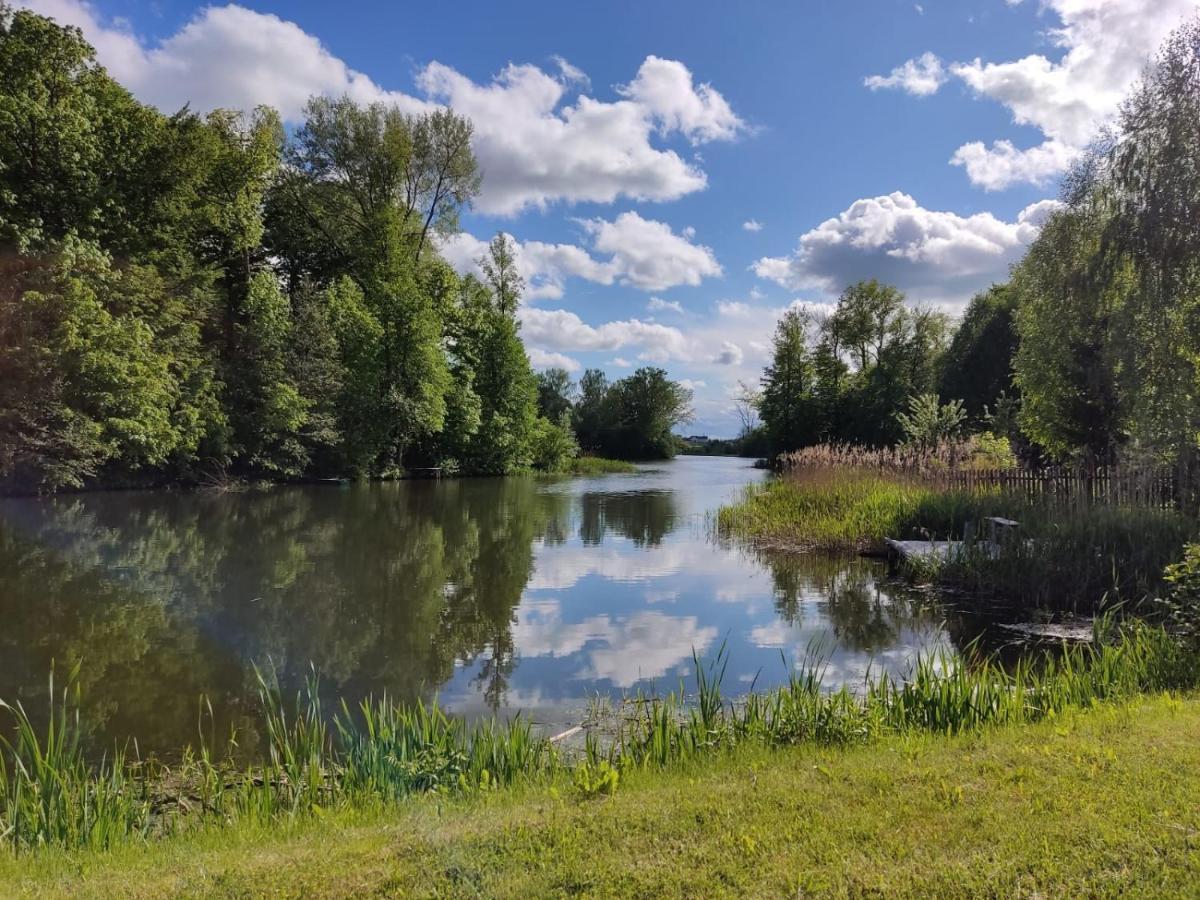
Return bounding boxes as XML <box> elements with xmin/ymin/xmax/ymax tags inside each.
<box><xmin>1013</xmin><ymin>19</ymin><xmax>1200</xmax><ymax>462</ymax></box>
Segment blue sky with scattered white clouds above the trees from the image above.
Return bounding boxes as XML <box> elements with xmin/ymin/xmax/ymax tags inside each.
<box><xmin>17</xmin><ymin>0</ymin><xmax>1196</xmax><ymax>436</ymax></box>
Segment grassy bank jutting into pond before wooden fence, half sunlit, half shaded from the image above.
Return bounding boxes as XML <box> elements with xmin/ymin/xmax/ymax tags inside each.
<box><xmin>718</xmin><ymin>469</ymin><xmax>1198</xmax><ymax>611</ymax></box>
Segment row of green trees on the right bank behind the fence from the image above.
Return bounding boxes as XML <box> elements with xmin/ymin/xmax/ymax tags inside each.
<box><xmin>758</xmin><ymin>19</ymin><xmax>1200</xmax><ymax>464</ymax></box>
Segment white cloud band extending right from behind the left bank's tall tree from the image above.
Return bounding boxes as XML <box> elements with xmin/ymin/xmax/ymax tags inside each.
<box><xmin>438</xmin><ymin>212</ymin><xmax>721</xmax><ymax>297</ymax></box>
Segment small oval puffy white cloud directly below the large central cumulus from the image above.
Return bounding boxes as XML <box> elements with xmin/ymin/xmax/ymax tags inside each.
<box><xmin>582</xmin><ymin>212</ymin><xmax>721</xmax><ymax>290</ymax></box>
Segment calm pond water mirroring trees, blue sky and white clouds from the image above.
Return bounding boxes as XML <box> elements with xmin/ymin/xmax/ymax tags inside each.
<box><xmin>0</xmin><ymin>457</ymin><xmax>970</xmax><ymax>751</ymax></box>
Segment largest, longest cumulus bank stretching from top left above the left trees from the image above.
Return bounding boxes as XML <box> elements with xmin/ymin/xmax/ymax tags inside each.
<box><xmin>18</xmin><ymin>0</ymin><xmax>745</xmax><ymax>215</ymax></box>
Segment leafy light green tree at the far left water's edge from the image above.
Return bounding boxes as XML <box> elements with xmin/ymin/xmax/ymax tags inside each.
<box><xmin>0</xmin><ymin>239</ymin><xmax>221</xmax><ymax>490</ymax></box>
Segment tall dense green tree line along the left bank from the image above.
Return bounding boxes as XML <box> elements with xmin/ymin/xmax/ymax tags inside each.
<box><xmin>0</xmin><ymin>2</ymin><xmax>686</xmax><ymax>491</ymax></box>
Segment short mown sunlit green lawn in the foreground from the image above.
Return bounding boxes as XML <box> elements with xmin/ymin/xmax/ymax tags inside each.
<box><xmin>9</xmin><ymin>697</ymin><xmax>1200</xmax><ymax>898</ymax></box>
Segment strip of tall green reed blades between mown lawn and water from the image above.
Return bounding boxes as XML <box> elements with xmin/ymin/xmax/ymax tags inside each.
<box><xmin>0</xmin><ymin>619</ymin><xmax>1200</xmax><ymax>853</ymax></box>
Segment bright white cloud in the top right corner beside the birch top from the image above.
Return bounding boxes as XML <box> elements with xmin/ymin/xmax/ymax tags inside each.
<box><xmin>949</xmin><ymin>0</ymin><xmax>1196</xmax><ymax>190</ymax></box>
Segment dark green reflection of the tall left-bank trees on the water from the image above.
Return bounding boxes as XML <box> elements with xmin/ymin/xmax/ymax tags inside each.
<box><xmin>0</xmin><ymin>479</ymin><xmax>569</xmax><ymax>751</ymax></box>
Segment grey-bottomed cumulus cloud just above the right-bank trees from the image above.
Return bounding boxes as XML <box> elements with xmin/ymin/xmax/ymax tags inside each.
<box><xmin>752</xmin><ymin>192</ymin><xmax>1056</xmax><ymax>301</ymax></box>
